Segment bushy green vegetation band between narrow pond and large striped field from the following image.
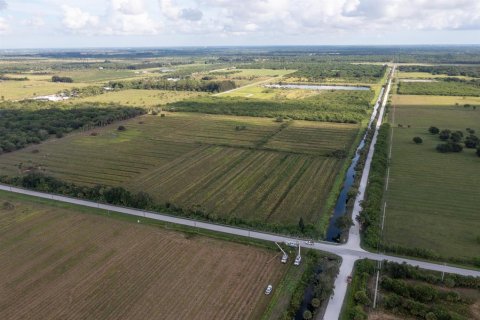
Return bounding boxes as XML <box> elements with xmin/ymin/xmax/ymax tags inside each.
<box><xmin>167</xmin><ymin>91</ymin><xmax>374</xmax><ymax>123</ymax></box>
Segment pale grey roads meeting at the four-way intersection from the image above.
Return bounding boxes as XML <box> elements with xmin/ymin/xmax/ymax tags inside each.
<box><xmin>0</xmin><ymin>66</ymin><xmax>480</xmax><ymax>320</ymax></box>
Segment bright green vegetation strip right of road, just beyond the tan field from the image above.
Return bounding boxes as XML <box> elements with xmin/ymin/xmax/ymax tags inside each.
<box><xmin>398</xmin><ymin>78</ymin><xmax>480</xmax><ymax>97</ymax></box>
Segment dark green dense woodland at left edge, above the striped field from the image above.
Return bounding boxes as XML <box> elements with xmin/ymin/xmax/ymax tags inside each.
<box><xmin>0</xmin><ymin>102</ymin><xmax>145</xmax><ymax>153</ymax></box>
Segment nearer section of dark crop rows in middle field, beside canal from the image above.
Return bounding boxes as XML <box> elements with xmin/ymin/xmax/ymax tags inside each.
<box><xmin>132</xmin><ymin>147</ymin><xmax>339</xmax><ymax>223</ymax></box>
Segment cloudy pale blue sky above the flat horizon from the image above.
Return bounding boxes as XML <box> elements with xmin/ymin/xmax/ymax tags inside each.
<box><xmin>0</xmin><ymin>0</ymin><xmax>480</xmax><ymax>49</ymax></box>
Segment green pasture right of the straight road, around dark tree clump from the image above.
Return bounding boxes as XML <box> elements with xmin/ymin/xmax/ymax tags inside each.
<box><xmin>385</xmin><ymin>96</ymin><xmax>480</xmax><ymax>258</ymax></box>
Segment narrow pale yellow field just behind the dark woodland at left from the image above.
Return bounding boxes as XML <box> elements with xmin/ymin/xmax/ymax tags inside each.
<box><xmin>73</xmin><ymin>89</ymin><xmax>207</xmax><ymax>107</ymax></box>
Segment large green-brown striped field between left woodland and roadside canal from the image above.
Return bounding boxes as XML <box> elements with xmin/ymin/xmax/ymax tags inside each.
<box><xmin>0</xmin><ymin>113</ymin><xmax>359</xmax><ymax>226</ymax></box>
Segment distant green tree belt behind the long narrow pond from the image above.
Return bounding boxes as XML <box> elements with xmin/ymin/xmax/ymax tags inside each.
<box><xmin>236</xmin><ymin>60</ymin><xmax>387</xmax><ymax>82</ymax></box>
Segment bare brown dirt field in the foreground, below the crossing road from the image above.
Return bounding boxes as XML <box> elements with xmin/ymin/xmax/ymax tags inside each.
<box><xmin>0</xmin><ymin>194</ymin><xmax>285</xmax><ymax>320</ymax></box>
